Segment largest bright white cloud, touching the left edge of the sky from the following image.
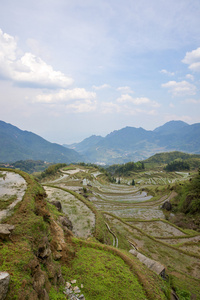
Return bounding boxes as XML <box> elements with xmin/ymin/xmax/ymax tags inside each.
<box><xmin>0</xmin><ymin>29</ymin><xmax>73</xmax><ymax>88</ymax></box>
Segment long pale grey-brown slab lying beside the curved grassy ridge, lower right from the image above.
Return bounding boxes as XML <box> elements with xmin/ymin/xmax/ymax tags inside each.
<box><xmin>129</xmin><ymin>249</ymin><xmax>165</xmax><ymax>278</ymax></box>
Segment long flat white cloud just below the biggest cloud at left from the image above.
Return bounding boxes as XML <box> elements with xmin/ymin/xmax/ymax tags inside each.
<box><xmin>34</xmin><ymin>88</ymin><xmax>96</xmax><ymax>103</ymax></box>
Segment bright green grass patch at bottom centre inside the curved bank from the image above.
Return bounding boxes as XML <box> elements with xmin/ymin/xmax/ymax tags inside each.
<box><xmin>61</xmin><ymin>247</ymin><xmax>147</xmax><ymax>300</ymax></box>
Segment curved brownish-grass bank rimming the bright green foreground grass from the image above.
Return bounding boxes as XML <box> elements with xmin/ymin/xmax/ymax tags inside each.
<box><xmin>73</xmin><ymin>238</ymin><xmax>166</xmax><ymax>300</ymax></box>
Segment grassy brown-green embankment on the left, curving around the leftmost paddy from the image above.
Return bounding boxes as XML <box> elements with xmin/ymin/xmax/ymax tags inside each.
<box><xmin>0</xmin><ymin>169</ymin><xmax>50</xmax><ymax>300</ymax></box>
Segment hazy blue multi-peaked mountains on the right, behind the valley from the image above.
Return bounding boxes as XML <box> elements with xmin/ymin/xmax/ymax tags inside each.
<box><xmin>65</xmin><ymin>121</ymin><xmax>200</xmax><ymax>164</ymax></box>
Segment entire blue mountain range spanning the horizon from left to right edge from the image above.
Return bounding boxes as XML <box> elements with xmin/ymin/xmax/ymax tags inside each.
<box><xmin>0</xmin><ymin>121</ymin><xmax>200</xmax><ymax>164</ymax></box>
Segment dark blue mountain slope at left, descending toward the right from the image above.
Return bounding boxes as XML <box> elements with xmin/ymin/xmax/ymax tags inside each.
<box><xmin>0</xmin><ymin>121</ymin><xmax>83</xmax><ymax>163</ymax></box>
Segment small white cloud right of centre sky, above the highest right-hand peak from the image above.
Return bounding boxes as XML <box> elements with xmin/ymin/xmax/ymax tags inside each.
<box><xmin>161</xmin><ymin>80</ymin><xmax>196</xmax><ymax>96</ymax></box>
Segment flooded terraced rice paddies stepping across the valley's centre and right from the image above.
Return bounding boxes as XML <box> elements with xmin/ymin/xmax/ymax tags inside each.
<box><xmin>45</xmin><ymin>168</ymin><xmax>200</xmax><ymax>299</ymax></box>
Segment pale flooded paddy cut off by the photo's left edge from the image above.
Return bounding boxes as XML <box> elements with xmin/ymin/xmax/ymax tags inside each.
<box><xmin>0</xmin><ymin>172</ymin><xmax>27</xmax><ymax>222</ymax></box>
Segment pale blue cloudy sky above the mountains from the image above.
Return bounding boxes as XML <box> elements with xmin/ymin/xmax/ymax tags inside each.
<box><xmin>0</xmin><ymin>0</ymin><xmax>200</xmax><ymax>144</ymax></box>
